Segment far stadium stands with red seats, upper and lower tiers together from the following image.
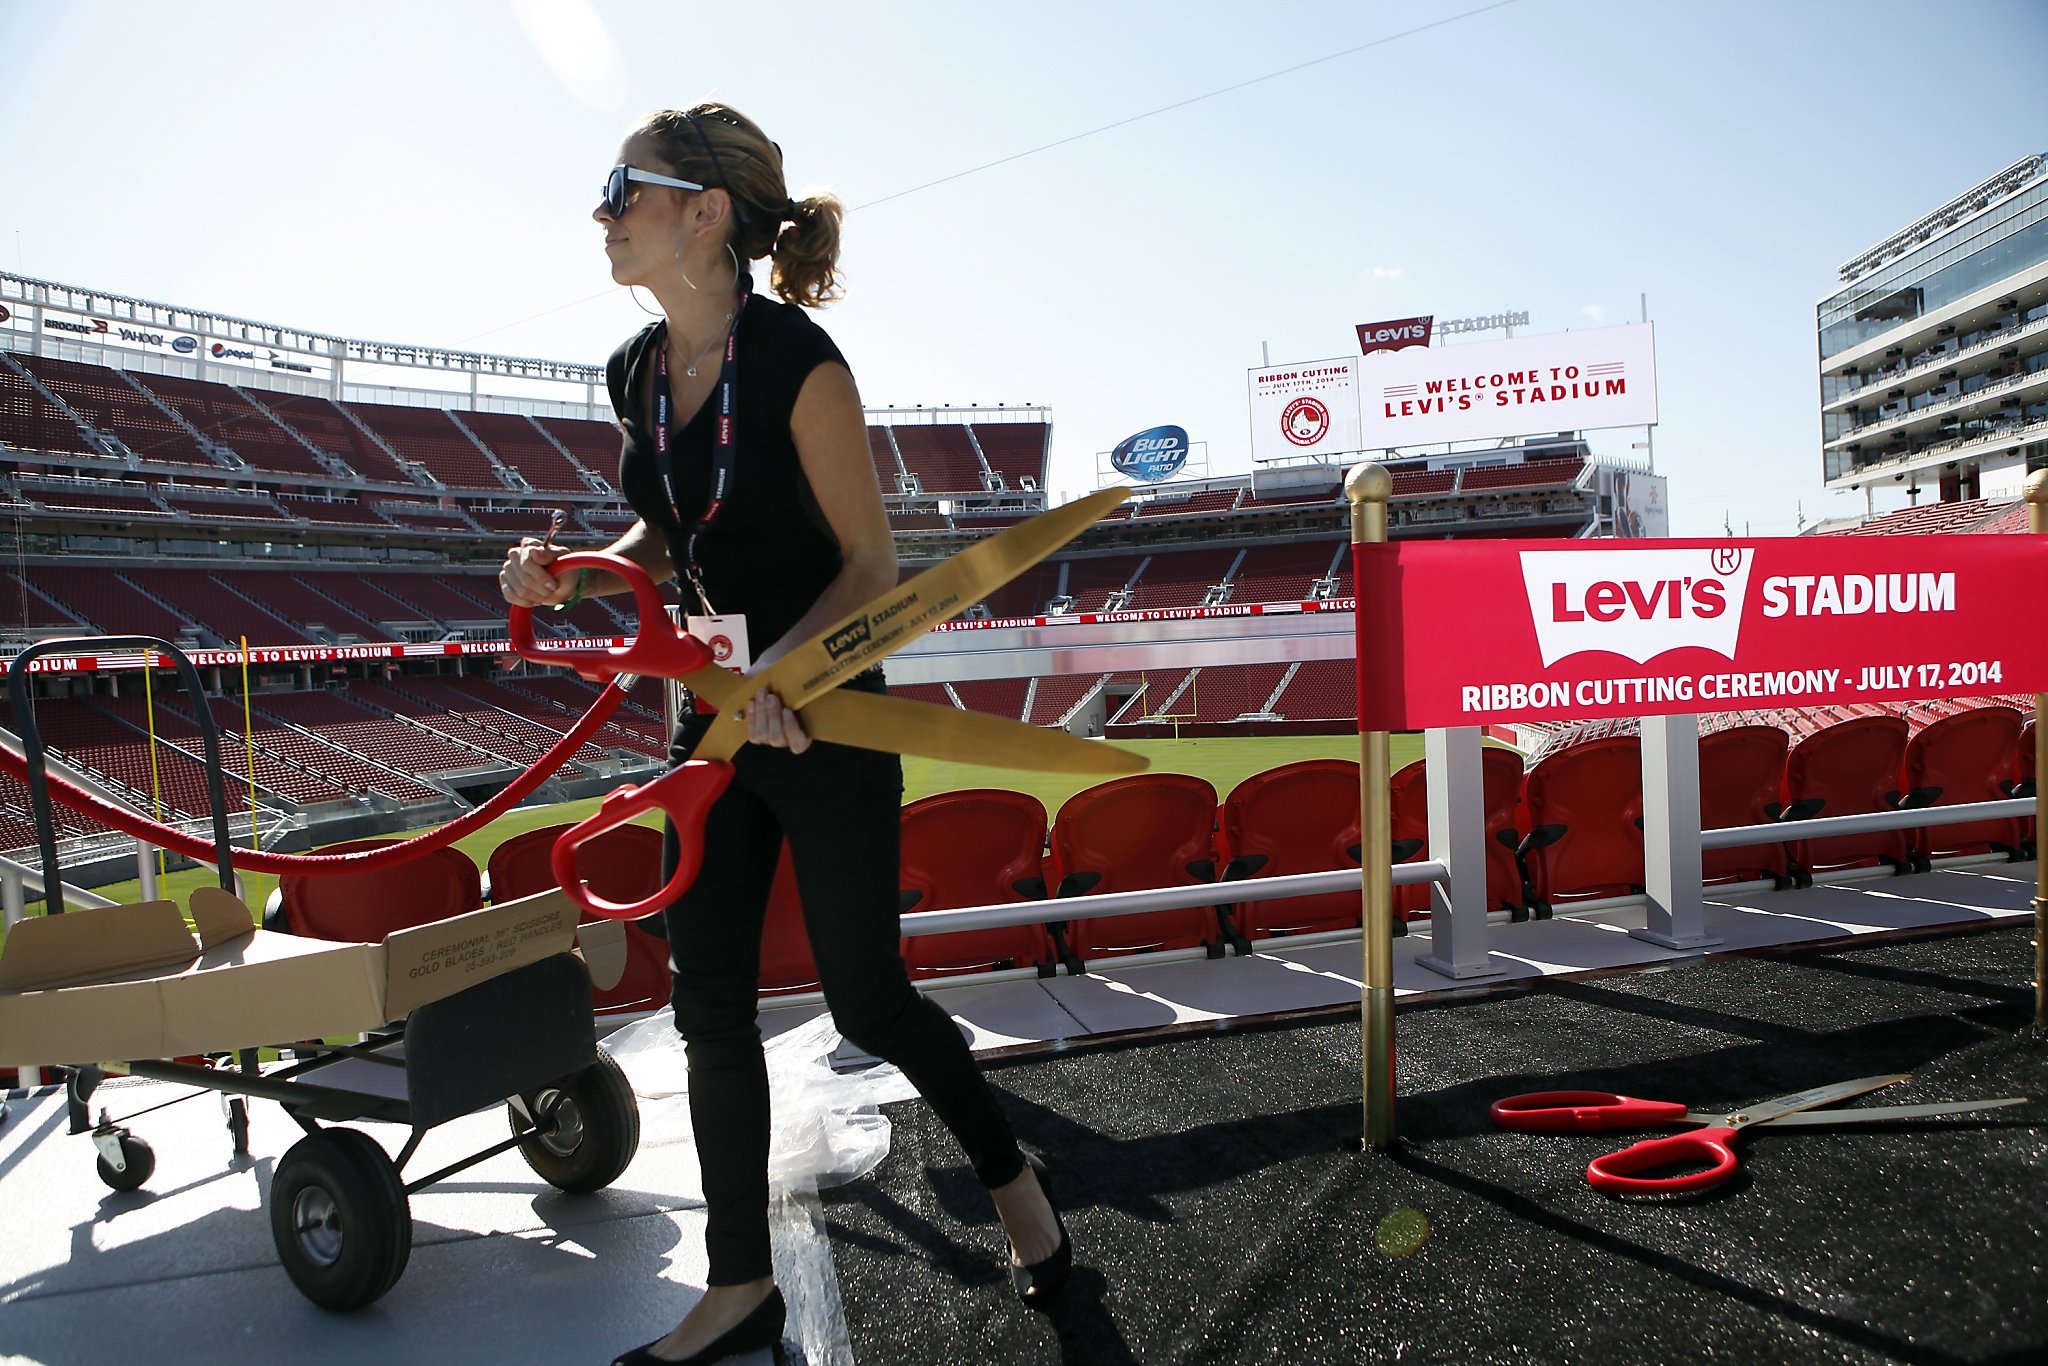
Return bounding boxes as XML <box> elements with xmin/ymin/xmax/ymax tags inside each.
<box><xmin>0</xmin><ymin>274</ymin><xmax>1645</xmax><ymax>860</ymax></box>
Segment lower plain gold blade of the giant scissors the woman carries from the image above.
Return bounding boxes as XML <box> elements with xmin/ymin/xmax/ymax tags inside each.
<box><xmin>799</xmin><ymin>690</ymin><xmax>1151</xmax><ymax>776</ymax></box>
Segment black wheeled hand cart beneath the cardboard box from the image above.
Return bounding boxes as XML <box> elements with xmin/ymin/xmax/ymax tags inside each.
<box><xmin>8</xmin><ymin>637</ymin><xmax>639</xmax><ymax>1309</ymax></box>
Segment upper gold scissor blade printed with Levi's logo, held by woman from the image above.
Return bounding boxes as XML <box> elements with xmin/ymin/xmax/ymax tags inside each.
<box><xmin>688</xmin><ymin>487</ymin><xmax>1130</xmax><ymax>760</ymax></box>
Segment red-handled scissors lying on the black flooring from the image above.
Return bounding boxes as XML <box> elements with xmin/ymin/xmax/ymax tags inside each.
<box><xmin>1491</xmin><ymin>1073</ymin><xmax>2028</xmax><ymax>1196</ymax></box>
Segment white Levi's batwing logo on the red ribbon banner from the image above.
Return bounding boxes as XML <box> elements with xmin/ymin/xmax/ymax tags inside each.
<box><xmin>1522</xmin><ymin>549</ymin><xmax>1755</xmax><ymax>668</ymax></box>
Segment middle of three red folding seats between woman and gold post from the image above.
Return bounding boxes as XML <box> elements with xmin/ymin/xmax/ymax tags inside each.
<box><xmin>1047</xmin><ymin>774</ymin><xmax>1225</xmax><ymax>961</ymax></box>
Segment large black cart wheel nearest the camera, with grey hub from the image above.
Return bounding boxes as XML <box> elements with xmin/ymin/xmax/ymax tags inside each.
<box><xmin>270</xmin><ymin>1128</ymin><xmax>412</xmax><ymax>1309</ymax></box>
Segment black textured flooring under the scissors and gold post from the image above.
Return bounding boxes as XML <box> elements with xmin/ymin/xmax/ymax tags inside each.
<box><xmin>825</xmin><ymin>928</ymin><xmax>2048</xmax><ymax>1366</ymax></box>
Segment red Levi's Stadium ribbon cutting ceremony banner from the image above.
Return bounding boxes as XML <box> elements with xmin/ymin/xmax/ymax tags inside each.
<box><xmin>1356</xmin><ymin>537</ymin><xmax>2048</xmax><ymax>731</ymax></box>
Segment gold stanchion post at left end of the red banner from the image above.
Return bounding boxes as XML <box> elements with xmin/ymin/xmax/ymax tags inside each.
<box><xmin>1343</xmin><ymin>461</ymin><xmax>1395</xmax><ymax>1151</ymax></box>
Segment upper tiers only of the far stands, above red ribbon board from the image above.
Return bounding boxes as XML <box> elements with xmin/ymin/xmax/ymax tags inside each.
<box><xmin>0</xmin><ymin>274</ymin><xmax>1628</xmax><ymax>645</ymax></box>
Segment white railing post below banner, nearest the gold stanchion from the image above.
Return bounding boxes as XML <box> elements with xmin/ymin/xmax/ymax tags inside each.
<box><xmin>1415</xmin><ymin>725</ymin><xmax>1507</xmax><ymax>981</ymax></box>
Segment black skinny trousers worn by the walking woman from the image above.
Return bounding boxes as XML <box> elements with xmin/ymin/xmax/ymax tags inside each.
<box><xmin>664</xmin><ymin>680</ymin><xmax>1024</xmax><ymax>1286</ymax></box>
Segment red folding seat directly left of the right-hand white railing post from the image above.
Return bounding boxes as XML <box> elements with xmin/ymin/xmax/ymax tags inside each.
<box><xmin>1522</xmin><ymin>735</ymin><xmax>1642</xmax><ymax>920</ymax></box>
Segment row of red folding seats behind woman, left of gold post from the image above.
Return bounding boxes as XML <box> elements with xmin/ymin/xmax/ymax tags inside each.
<box><xmin>256</xmin><ymin>760</ymin><xmax>1358</xmax><ymax>1012</ymax></box>
